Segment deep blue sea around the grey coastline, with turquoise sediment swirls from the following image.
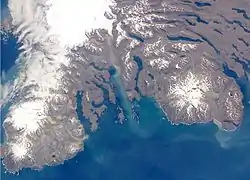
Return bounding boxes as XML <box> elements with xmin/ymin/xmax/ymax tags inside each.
<box><xmin>1</xmin><ymin>0</ymin><xmax>250</xmax><ymax>180</ymax></box>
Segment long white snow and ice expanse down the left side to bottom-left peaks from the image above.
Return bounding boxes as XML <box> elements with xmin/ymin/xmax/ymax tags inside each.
<box><xmin>4</xmin><ymin>0</ymin><xmax>114</xmax><ymax>158</ymax></box>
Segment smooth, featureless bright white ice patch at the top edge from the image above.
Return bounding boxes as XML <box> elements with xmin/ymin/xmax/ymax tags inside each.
<box><xmin>46</xmin><ymin>0</ymin><xmax>112</xmax><ymax>46</ymax></box>
